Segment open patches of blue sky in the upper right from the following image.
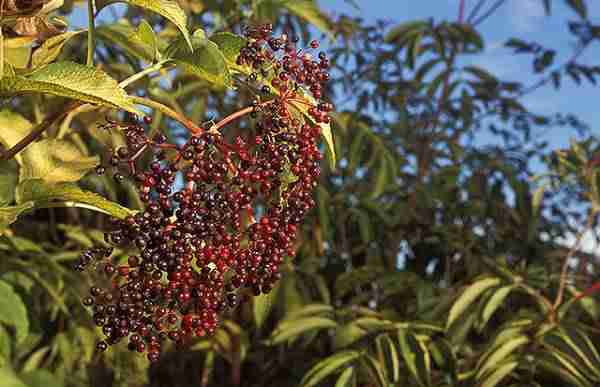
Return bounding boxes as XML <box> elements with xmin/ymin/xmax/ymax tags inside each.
<box><xmin>319</xmin><ymin>0</ymin><xmax>600</xmax><ymax>148</ymax></box>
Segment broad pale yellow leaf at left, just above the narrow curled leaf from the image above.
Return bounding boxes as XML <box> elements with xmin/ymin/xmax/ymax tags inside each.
<box><xmin>20</xmin><ymin>139</ymin><xmax>100</xmax><ymax>183</ymax></box>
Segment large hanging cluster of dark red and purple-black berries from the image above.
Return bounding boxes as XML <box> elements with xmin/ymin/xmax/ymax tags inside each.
<box><xmin>76</xmin><ymin>25</ymin><xmax>332</xmax><ymax>361</ymax></box>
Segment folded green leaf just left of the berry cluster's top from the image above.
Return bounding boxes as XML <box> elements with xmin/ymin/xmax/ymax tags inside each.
<box><xmin>165</xmin><ymin>29</ymin><xmax>231</xmax><ymax>88</ymax></box>
